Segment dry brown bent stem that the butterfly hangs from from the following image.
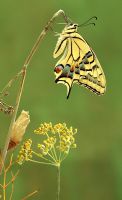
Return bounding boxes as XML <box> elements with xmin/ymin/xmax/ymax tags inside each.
<box><xmin>0</xmin><ymin>10</ymin><xmax>69</xmax><ymax>174</ymax></box>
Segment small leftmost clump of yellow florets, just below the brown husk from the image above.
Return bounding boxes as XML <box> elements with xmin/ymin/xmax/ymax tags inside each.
<box><xmin>17</xmin><ymin>139</ymin><xmax>32</xmax><ymax>165</ymax></box>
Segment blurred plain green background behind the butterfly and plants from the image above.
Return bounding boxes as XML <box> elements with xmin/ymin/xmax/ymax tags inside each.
<box><xmin>0</xmin><ymin>0</ymin><xmax>122</xmax><ymax>200</ymax></box>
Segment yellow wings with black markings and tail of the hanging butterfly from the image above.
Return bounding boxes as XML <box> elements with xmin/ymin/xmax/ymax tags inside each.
<box><xmin>53</xmin><ymin>25</ymin><xmax>106</xmax><ymax>98</ymax></box>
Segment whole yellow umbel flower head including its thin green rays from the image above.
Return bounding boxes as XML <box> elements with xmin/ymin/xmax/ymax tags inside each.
<box><xmin>17</xmin><ymin>122</ymin><xmax>77</xmax><ymax>166</ymax></box>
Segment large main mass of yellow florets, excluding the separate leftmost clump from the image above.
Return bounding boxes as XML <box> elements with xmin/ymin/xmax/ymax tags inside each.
<box><xmin>34</xmin><ymin>122</ymin><xmax>77</xmax><ymax>155</ymax></box>
